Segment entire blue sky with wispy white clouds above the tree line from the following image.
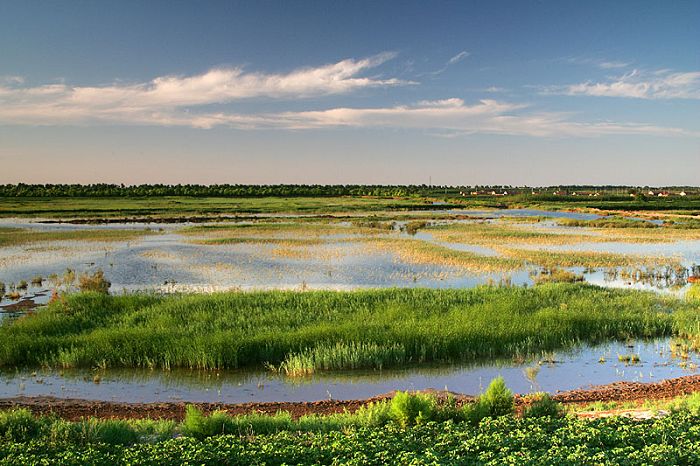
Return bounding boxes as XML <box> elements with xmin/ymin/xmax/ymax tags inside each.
<box><xmin>0</xmin><ymin>0</ymin><xmax>700</xmax><ymax>185</ymax></box>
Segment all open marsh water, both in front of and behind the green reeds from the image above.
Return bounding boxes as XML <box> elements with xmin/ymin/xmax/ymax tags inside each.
<box><xmin>0</xmin><ymin>210</ymin><xmax>700</xmax><ymax>403</ymax></box>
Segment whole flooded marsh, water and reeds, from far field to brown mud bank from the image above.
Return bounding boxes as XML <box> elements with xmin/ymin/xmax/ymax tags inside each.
<box><xmin>0</xmin><ymin>202</ymin><xmax>700</xmax><ymax>401</ymax></box>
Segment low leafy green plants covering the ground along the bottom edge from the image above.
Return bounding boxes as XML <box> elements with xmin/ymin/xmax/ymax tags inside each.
<box><xmin>0</xmin><ymin>412</ymin><xmax>700</xmax><ymax>465</ymax></box>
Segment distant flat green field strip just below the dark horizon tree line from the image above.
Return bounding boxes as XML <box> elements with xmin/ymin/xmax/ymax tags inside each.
<box><xmin>0</xmin><ymin>196</ymin><xmax>700</xmax><ymax>220</ymax></box>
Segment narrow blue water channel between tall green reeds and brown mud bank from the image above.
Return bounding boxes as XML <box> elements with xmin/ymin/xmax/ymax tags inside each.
<box><xmin>0</xmin><ymin>339</ymin><xmax>697</xmax><ymax>403</ymax></box>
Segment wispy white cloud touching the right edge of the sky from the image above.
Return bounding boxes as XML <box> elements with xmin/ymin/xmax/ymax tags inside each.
<box><xmin>543</xmin><ymin>70</ymin><xmax>700</xmax><ymax>99</ymax></box>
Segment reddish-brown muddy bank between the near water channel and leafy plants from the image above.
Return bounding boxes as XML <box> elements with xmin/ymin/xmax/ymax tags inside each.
<box><xmin>0</xmin><ymin>375</ymin><xmax>700</xmax><ymax>420</ymax></box>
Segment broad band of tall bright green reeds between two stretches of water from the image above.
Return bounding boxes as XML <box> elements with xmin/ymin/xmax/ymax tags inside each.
<box><xmin>0</xmin><ymin>284</ymin><xmax>700</xmax><ymax>372</ymax></box>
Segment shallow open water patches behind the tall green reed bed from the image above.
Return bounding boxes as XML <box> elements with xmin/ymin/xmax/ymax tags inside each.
<box><xmin>0</xmin><ymin>209</ymin><xmax>700</xmax><ymax>308</ymax></box>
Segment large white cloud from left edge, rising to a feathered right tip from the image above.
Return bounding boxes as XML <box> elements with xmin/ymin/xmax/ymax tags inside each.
<box><xmin>0</xmin><ymin>53</ymin><xmax>408</xmax><ymax>124</ymax></box>
